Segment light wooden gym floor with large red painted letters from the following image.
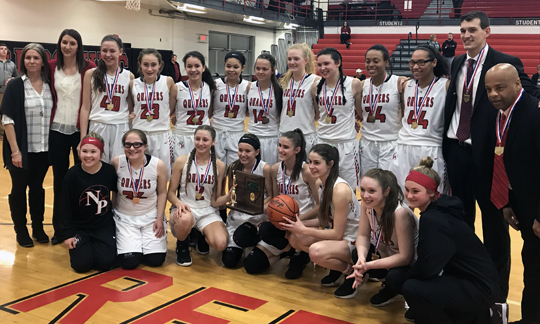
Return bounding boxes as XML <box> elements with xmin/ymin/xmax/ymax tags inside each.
<box><xmin>0</xmin><ymin>140</ymin><xmax>523</xmax><ymax>324</ymax></box>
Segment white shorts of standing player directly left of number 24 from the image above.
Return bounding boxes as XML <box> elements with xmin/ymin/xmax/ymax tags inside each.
<box><xmin>319</xmin><ymin>139</ymin><xmax>360</xmax><ymax>190</ymax></box>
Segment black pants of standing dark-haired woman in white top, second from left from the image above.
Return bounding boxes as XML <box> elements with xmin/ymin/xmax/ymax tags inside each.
<box><xmin>49</xmin><ymin>130</ymin><xmax>81</xmax><ymax>237</ymax></box>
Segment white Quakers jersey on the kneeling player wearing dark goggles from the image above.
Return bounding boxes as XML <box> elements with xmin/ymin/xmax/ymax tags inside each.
<box><xmin>116</xmin><ymin>154</ymin><xmax>159</xmax><ymax>216</ymax></box>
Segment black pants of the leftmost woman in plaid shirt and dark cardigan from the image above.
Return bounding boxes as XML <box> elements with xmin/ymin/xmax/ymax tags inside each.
<box><xmin>9</xmin><ymin>152</ymin><xmax>49</xmax><ymax>231</ymax></box>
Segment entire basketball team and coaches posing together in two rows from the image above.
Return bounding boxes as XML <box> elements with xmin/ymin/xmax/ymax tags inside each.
<box><xmin>0</xmin><ymin>11</ymin><xmax>540</xmax><ymax>324</ymax></box>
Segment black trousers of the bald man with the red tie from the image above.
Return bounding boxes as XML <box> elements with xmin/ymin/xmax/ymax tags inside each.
<box><xmin>510</xmin><ymin>191</ymin><xmax>540</xmax><ymax>323</ymax></box>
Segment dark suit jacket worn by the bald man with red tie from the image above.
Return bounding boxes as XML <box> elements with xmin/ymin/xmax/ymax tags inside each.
<box><xmin>473</xmin><ymin>93</ymin><xmax>540</xmax><ymax>226</ymax></box>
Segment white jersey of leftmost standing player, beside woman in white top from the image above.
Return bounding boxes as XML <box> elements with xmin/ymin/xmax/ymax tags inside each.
<box><xmin>88</xmin><ymin>69</ymin><xmax>131</xmax><ymax>124</ymax></box>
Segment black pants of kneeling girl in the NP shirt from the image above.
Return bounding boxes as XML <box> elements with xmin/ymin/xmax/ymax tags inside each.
<box><xmin>69</xmin><ymin>224</ymin><xmax>116</xmax><ymax>272</ymax></box>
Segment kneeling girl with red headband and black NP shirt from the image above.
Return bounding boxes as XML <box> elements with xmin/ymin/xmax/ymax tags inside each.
<box><xmin>60</xmin><ymin>132</ymin><xmax>117</xmax><ymax>272</ymax></box>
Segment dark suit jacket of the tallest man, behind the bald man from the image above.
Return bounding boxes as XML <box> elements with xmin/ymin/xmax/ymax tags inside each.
<box><xmin>443</xmin><ymin>47</ymin><xmax>540</xmax><ymax>161</ymax></box>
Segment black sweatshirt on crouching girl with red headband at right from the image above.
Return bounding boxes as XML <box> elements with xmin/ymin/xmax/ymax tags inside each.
<box><xmin>408</xmin><ymin>195</ymin><xmax>499</xmax><ymax>296</ymax></box>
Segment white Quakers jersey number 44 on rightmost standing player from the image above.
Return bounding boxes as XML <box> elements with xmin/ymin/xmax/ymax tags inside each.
<box><xmin>398</xmin><ymin>78</ymin><xmax>447</xmax><ymax>146</ymax></box>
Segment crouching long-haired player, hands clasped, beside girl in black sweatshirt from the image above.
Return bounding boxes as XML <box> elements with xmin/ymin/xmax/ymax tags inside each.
<box><xmin>346</xmin><ymin>169</ymin><xmax>418</xmax><ymax>306</ymax></box>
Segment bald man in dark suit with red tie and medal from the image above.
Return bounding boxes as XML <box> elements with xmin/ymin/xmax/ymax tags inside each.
<box><xmin>480</xmin><ymin>63</ymin><xmax>540</xmax><ymax>324</ymax></box>
